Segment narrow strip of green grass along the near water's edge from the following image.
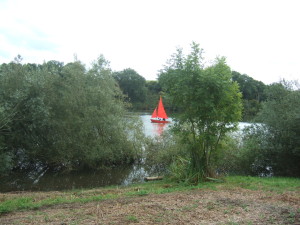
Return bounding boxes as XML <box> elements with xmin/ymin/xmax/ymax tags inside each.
<box><xmin>0</xmin><ymin>176</ymin><xmax>300</xmax><ymax>214</ymax></box>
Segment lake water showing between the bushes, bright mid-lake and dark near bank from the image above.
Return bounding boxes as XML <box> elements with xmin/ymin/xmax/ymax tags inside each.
<box><xmin>0</xmin><ymin>113</ymin><xmax>248</xmax><ymax>192</ymax></box>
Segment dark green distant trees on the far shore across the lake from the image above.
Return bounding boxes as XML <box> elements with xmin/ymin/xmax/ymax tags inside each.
<box><xmin>113</xmin><ymin>66</ymin><xmax>268</xmax><ymax>121</ymax></box>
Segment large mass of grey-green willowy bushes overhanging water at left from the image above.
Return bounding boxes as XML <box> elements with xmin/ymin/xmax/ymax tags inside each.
<box><xmin>0</xmin><ymin>56</ymin><xmax>144</xmax><ymax>169</ymax></box>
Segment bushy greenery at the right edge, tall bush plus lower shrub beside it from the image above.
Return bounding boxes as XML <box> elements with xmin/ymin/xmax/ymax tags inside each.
<box><xmin>229</xmin><ymin>81</ymin><xmax>300</xmax><ymax>176</ymax></box>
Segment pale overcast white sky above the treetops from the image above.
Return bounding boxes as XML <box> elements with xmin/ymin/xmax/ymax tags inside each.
<box><xmin>0</xmin><ymin>0</ymin><xmax>300</xmax><ymax>84</ymax></box>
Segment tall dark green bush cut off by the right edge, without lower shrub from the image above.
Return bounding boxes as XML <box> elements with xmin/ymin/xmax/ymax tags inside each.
<box><xmin>258</xmin><ymin>81</ymin><xmax>300</xmax><ymax>176</ymax></box>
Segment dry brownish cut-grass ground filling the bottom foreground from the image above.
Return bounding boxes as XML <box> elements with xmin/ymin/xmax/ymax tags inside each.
<box><xmin>0</xmin><ymin>188</ymin><xmax>300</xmax><ymax>225</ymax></box>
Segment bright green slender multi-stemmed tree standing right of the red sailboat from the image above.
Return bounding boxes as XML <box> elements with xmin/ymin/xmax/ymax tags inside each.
<box><xmin>159</xmin><ymin>43</ymin><xmax>242</xmax><ymax>182</ymax></box>
